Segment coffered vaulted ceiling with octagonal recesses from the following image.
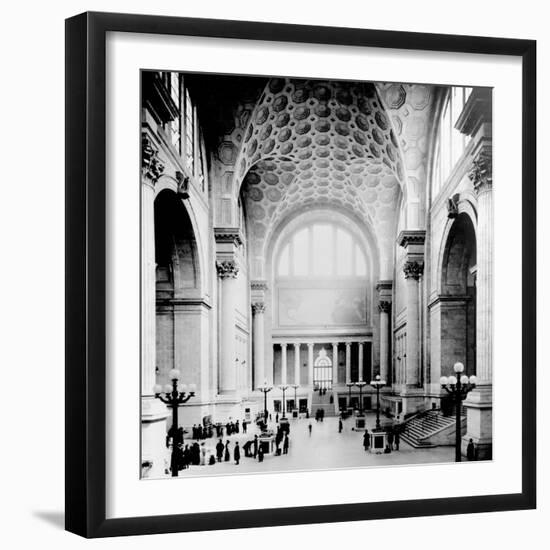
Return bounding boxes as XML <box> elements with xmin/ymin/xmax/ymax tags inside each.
<box><xmin>205</xmin><ymin>78</ymin><xmax>434</xmax><ymax>280</ymax></box>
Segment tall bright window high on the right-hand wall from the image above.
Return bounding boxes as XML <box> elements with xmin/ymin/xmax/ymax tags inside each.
<box><xmin>433</xmin><ymin>87</ymin><xmax>472</xmax><ymax>197</ymax></box>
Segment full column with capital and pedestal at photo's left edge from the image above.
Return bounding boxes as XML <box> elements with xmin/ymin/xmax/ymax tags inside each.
<box><xmin>141</xmin><ymin>133</ymin><xmax>168</xmax><ymax>478</ymax></box>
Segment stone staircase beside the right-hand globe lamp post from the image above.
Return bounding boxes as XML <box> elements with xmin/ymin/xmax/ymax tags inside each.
<box><xmin>401</xmin><ymin>410</ymin><xmax>466</xmax><ymax>449</ymax></box>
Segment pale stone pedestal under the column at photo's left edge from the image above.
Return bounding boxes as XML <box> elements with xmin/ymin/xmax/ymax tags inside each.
<box><xmin>141</xmin><ymin>396</ymin><xmax>170</xmax><ymax>478</ymax></box>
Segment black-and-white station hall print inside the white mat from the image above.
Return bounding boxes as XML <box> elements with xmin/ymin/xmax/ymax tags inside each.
<box><xmin>140</xmin><ymin>72</ymin><xmax>498</xmax><ymax>481</ymax></box>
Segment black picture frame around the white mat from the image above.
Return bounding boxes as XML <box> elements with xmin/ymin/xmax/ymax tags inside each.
<box><xmin>65</xmin><ymin>13</ymin><xmax>536</xmax><ymax>537</ymax></box>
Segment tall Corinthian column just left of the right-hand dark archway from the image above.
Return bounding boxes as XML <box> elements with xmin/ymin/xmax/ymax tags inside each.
<box><xmin>403</xmin><ymin>261</ymin><xmax>424</xmax><ymax>387</ymax></box>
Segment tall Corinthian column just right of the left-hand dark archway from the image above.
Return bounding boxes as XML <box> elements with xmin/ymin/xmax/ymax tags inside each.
<box><xmin>216</xmin><ymin>260</ymin><xmax>239</xmax><ymax>394</ymax></box>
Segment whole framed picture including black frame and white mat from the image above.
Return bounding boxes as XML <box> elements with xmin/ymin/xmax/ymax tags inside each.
<box><xmin>66</xmin><ymin>13</ymin><xmax>536</xmax><ymax>537</ymax></box>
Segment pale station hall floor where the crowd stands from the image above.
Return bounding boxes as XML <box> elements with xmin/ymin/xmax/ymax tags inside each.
<box><xmin>163</xmin><ymin>414</ymin><xmax>454</xmax><ymax>477</ymax></box>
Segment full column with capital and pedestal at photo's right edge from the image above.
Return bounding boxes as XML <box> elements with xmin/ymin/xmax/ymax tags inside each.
<box><xmin>462</xmin><ymin>145</ymin><xmax>494</xmax><ymax>459</ymax></box>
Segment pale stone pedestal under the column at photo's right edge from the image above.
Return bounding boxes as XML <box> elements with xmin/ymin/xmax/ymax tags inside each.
<box><xmin>462</xmin><ymin>384</ymin><xmax>493</xmax><ymax>460</ymax></box>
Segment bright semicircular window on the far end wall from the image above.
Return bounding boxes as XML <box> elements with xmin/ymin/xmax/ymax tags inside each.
<box><xmin>276</xmin><ymin>223</ymin><xmax>367</xmax><ymax>277</ymax></box>
